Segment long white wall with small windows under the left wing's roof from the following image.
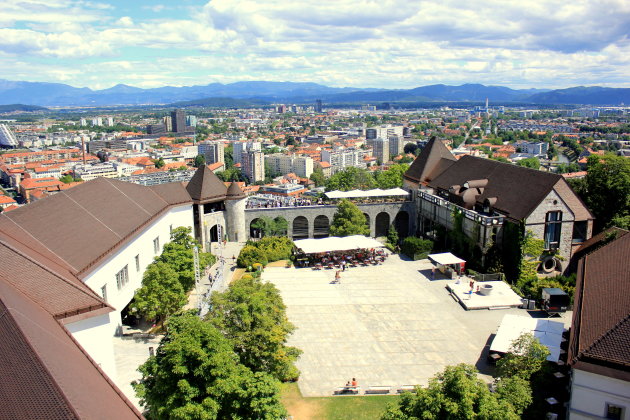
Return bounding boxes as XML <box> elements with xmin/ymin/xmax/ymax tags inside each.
<box><xmin>83</xmin><ymin>204</ymin><xmax>193</xmax><ymax>335</ymax></box>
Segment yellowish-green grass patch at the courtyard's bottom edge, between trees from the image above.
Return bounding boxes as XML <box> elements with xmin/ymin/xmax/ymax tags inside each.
<box><xmin>281</xmin><ymin>383</ymin><xmax>398</xmax><ymax>420</ymax></box>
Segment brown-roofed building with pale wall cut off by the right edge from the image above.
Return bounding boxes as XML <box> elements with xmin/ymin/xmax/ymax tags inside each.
<box><xmin>568</xmin><ymin>230</ymin><xmax>630</xmax><ymax>420</ymax></box>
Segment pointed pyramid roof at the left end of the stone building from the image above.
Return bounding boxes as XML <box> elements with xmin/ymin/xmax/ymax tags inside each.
<box><xmin>404</xmin><ymin>137</ymin><xmax>456</xmax><ymax>184</ymax></box>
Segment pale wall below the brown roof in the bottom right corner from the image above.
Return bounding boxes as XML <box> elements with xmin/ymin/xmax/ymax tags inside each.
<box><xmin>570</xmin><ymin>369</ymin><xmax>630</xmax><ymax>420</ymax></box>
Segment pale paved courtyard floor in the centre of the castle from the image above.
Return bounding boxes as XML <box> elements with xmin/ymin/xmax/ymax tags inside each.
<box><xmin>263</xmin><ymin>255</ymin><xmax>570</xmax><ymax>397</ymax></box>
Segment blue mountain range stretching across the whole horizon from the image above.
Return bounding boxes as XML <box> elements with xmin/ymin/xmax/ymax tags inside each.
<box><xmin>0</xmin><ymin>79</ymin><xmax>630</xmax><ymax>106</ymax></box>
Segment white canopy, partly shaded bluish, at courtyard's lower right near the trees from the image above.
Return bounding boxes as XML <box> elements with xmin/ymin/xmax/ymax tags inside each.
<box><xmin>490</xmin><ymin>314</ymin><xmax>564</xmax><ymax>362</ymax></box>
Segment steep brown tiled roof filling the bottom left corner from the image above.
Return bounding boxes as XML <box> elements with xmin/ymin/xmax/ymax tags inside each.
<box><xmin>0</xmin><ymin>276</ymin><xmax>142</xmax><ymax>420</ymax></box>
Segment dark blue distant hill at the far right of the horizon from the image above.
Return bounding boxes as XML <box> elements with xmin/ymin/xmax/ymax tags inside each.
<box><xmin>528</xmin><ymin>86</ymin><xmax>630</xmax><ymax>105</ymax></box>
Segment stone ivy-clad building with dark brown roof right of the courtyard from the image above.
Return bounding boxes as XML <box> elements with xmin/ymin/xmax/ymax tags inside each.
<box><xmin>404</xmin><ymin>138</ymin><xmax>593</xmax><ymax>274</ymax></box>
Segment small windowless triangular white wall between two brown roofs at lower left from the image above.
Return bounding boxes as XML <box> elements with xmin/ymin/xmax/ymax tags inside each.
<box><xmin>65</xmin><ymin>314</ymin><xmax>116</xmax><ymax>378</ymax></box>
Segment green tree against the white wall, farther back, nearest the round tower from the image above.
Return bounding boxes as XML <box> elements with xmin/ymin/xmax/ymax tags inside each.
<box><xmin>156</xmin><ymin>226</ymin><xmax>216</xmax><ymax>291</ymax></box>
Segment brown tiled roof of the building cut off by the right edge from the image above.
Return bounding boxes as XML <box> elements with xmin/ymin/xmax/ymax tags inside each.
<box><xmin>569</xmin><ymin>235</ymin><xmax>630</xmax><ymax>381</ymax></box>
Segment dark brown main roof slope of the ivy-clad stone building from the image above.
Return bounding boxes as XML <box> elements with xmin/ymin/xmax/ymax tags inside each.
<box><xmin>429</xmin><ymin>156</ymin><xmax>562</xmax><ymax>220</ymax></box>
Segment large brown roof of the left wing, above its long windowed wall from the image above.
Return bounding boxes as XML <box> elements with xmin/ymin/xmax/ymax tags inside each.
<box><xmin>0</xmin><ymin>178</ymin><xmax>191</xmax><ymax>278</ymax></box>
